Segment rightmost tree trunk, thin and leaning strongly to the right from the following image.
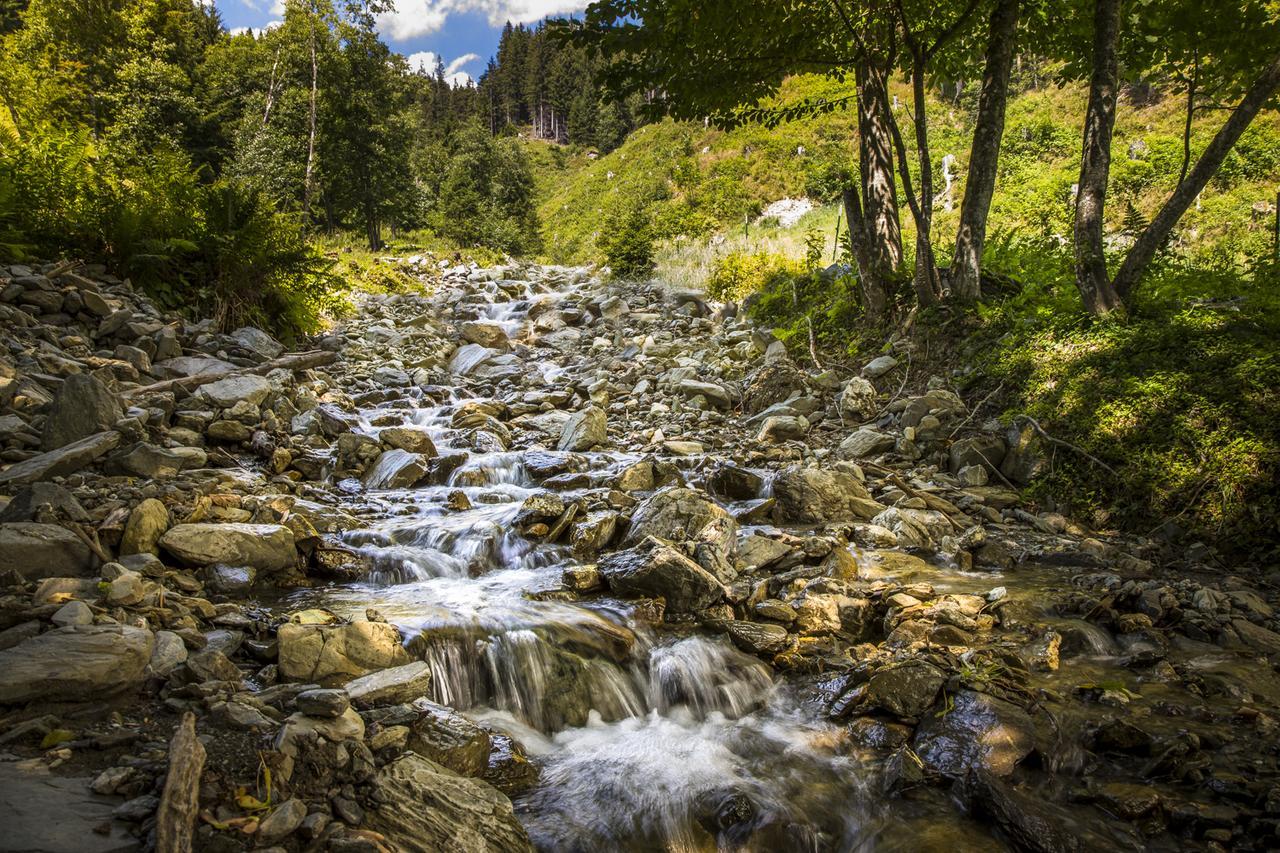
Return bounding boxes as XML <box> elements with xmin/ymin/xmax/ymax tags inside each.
<box><xmin>1115</xmin><ymin>53</ymin><xmax>1280</xmax><ymax>298</ymax></box>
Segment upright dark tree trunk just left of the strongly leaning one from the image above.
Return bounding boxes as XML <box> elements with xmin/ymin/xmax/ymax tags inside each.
<box><xmin>1075</xmin><ymin>0</ymin><xmax>1124</xmax><ymax>315</ymax></box>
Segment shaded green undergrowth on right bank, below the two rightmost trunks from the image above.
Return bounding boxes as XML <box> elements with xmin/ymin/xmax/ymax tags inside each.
<box><xmin>963</xmin><ymin>242</ymin><xmax>1280</xmax><ymax>556</ymax></box>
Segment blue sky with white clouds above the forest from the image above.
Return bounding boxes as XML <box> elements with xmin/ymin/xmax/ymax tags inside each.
<box><xmin>214</xmin><ymin>0</ymin><xmax>589</xmax><ymax>83</ymax></box>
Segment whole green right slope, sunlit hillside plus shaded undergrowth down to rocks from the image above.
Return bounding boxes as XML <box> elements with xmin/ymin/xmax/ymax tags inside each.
<box><xmin>519</xmin><ymin>77</ymin><xmax>1280</xmax><ymax>560</ymax></box>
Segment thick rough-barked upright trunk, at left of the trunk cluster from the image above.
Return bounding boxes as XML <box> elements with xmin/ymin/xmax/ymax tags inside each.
<box><xmin>856</xmin><ymin>57</ymin><xmax>902</xmax><ymax>273</ymax></box>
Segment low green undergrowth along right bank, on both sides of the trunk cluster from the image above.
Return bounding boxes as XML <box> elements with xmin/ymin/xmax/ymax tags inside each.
<box><xmin>709</xmin><ymin>227</ymin><xmax>1280</xmax><ymax>558</ymax></box>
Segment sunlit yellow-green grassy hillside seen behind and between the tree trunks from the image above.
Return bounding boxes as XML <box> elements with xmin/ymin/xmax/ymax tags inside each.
<box><xmin>529</xmin><ymin>76</ymin><xmax>1280</xmax><ymax>269</ymax></box>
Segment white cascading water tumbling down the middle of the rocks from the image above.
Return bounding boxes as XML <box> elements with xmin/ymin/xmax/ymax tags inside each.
<box><xmin>288</xmin><ymin>268</ymin><xmax>861</xmax><ymax>850</ymax></box>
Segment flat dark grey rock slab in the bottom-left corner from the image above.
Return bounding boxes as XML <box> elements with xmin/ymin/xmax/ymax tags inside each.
<box><xmin>0</xmin><ymin>762</ymin><xmax>142</xmax><ymax>853</ymax></box>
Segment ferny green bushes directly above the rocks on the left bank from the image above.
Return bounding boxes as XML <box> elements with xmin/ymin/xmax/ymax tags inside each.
<box><xmin>0</xmin><ymin>129</ymin><xmax>337</xmax><ymax>338</ymax></box>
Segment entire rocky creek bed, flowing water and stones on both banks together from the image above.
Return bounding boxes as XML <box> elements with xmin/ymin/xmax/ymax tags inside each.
<box><xmin>0</xmin><ymin>256</ymin><xmax>1280</xmax><ymax>853</ymax></box>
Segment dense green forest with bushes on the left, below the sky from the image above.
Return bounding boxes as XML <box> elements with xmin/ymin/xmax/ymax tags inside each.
<box><xmin>0</xmin><ymin>0</ymin><xmax>634</xmax><ymax>329</ymax></box>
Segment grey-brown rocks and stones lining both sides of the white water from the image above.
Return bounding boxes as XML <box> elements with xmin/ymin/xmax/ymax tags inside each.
<box><xmin>0</xmin><ymin>260</ymin><xmax>1280</xmax><ymax>850</ymax></box>
